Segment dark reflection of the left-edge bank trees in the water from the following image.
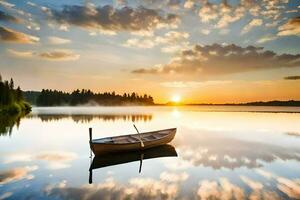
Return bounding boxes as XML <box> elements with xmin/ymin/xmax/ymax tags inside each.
<box><xmin>0</xmin><ymin>112</ymin><xmax>23</xmax><ymax>136</ymax></box>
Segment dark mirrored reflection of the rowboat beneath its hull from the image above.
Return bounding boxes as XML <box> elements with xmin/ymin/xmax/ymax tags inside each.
<box><xmin>89</xmin><ymin>144</ymin><xmax>177</xmax><ymax>184</ymax></box>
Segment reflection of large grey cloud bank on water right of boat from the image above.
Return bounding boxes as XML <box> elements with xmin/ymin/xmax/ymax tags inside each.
<box><xmin>177</xmin><ymin>129</ymin><xmax>300</xmax><ymax>169</ymax></box>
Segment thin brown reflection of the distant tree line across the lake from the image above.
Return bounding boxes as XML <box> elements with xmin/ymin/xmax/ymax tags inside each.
<box><xmin>28</xmin><ymin>114</ymin><xmax>152</xmax><ymax>123</ymax></box>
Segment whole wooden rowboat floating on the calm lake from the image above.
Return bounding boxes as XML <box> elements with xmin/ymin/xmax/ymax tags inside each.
<box><xmin>90</xmin><ymin>128</ymin><xmax>176</xmax><ymax>155</ymax></box>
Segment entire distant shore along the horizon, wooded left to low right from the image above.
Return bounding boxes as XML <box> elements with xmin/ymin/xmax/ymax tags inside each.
<box><xmin>23</xmin><ymin>89</ymin><xmax>300</xmax><ymax>107</ymax></box>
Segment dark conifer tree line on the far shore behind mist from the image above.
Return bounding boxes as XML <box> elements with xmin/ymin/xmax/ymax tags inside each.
<box><xmin>25</xmin><ymin>89</ymin><xmax>154</xmax><ymax>106</ymax></box>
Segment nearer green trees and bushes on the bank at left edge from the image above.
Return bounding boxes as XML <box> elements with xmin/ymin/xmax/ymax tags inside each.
<box><xmin>0</xmin><ymin>74</ymin><xmax>31</xmax><ymax>114</ymax></box>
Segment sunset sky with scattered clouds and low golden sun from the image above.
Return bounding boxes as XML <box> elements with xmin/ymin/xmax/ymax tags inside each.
<box><xmin>0</xmin><ymin>0</ymin><xmax>300</xmax><ymax>103</ymax></box>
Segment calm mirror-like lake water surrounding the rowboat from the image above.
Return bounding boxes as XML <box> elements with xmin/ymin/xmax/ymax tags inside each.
<box><xmin>0</xmin><ymin>106</ymin><xmax>300</xmax><ymax>199</ymax></box>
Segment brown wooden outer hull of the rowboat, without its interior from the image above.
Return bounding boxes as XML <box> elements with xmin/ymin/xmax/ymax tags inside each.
<box><xmin>90</xmin><ymin>129</ymin><xmax>176</xmax><ymax>155</ymax></box>
